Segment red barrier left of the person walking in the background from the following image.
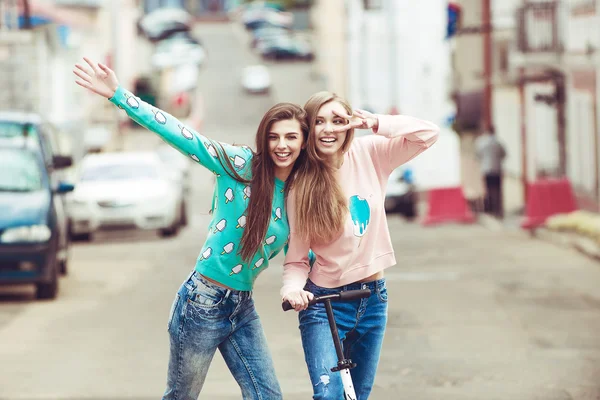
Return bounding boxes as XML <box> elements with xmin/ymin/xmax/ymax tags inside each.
<box><xmin>422</xmin><ymin>186</ymin><xmax>475</xmax><ymax>225</ymax></box>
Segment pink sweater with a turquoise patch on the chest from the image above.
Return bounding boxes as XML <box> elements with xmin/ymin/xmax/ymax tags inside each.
<box><xmin>281</xmin><ymin>115</ymin><xmax>439</xmax><ymax>297</ymax></box>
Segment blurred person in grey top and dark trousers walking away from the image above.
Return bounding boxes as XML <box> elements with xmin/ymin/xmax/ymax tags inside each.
<box><xmin>475</xmin><ymin>126</ymin><xmax>506</xmax><ymax>218</ymax></box>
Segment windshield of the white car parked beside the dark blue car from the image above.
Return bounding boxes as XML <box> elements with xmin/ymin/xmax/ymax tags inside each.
<box><xmin>81</xmin><ymin>163</ymin><xmax>159</xmax><ymax>181</ymax></box>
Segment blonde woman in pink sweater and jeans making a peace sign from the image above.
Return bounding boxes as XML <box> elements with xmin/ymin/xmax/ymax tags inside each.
<box><xmin>281</xmin><ymin>92</ymin><xmax>439</xmax><ymax>400</ymax></box>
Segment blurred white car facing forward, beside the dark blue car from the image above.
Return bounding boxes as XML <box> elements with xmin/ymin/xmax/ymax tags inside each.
<box><xmin>68</xmin><ymin>152</ymin><xmax>185</xmax><ymax>240</ymax></box>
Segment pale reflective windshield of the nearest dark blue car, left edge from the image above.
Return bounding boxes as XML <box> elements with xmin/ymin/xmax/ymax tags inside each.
<box><xmin>0</xmin><ymin>149</ymin><xmax>43</xmax><ymax>192</ymax></box>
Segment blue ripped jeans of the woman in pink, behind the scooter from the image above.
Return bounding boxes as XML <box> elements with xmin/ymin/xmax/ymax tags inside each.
<box><xmin>298</xmin><ymin>279</ymin><xmax>387</xmax><ymax>400</ymax></box>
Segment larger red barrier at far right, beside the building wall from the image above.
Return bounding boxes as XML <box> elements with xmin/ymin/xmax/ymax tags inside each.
<box><xmin>521</xmin><ymin>178</ymin><xmax>578</xmax><ymax>229</ymax></box>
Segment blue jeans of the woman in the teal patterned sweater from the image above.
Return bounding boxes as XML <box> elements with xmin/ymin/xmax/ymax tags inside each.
<box><xmin>163</xmin><ymin>271</ymin><xmax>283</xmax><ymax>400</ymax></box>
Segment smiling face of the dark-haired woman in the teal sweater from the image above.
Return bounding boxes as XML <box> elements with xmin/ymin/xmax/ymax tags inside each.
<box><xmin>267</xmin><ymin>119</ymin><xmax>304</xmax><ymax>180</ymax></box>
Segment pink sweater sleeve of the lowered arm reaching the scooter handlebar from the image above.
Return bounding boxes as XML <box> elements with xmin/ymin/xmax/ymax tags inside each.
<box><xmin>280</xmin><ymin>190</ymin><xmax>312</xmax><ymax>297</ymax></box>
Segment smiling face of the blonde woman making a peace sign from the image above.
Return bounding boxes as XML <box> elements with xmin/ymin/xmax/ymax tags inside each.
<box><xmin>314</xmin><ymin>101</ymin><xmax>348</xmax><ymax>158</ymax></box>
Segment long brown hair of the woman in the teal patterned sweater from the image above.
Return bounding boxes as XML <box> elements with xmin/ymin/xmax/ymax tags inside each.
<box><xmin>211</xmin><ymin>103</ymin><xmax>308</xmax><ymax>262</ymax></box>
